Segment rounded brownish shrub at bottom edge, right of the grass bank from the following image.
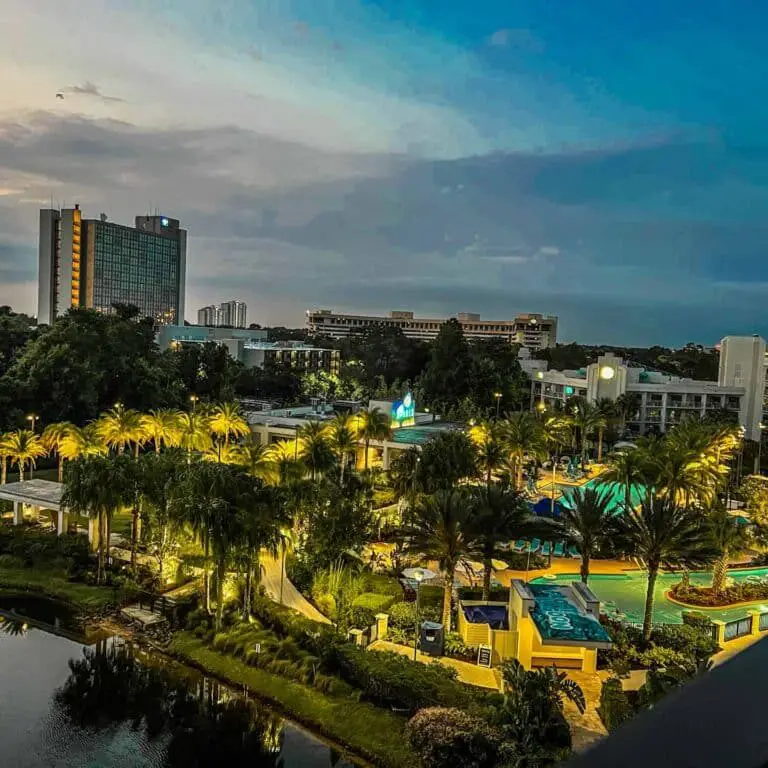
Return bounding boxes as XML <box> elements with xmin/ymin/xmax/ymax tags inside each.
<box><xmin>406</xmin><ymin>707</ymin><xmax>499</xmax><ymax>768</ymax></box>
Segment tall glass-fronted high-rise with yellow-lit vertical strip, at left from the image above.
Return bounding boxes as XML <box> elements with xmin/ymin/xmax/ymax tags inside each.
<box><xmin>38</xmin><ymin>205</ymin><xmax>187</xmax><ymax>325</ymax></box>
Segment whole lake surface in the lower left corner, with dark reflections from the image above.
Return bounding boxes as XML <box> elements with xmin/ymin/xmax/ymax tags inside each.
<box><xmin>0</xmin><ymin>624</ymin><xmax>351</xmax><ymax>768</ymax></box>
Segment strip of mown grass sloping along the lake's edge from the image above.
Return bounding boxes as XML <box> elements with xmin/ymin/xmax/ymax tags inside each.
<box><xmin>170</xmin><ymin>632</ymin><xmax>417</xmax><ymax>768</ymax></box>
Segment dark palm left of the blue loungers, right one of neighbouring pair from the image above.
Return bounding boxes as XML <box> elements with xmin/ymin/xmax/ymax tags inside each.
<box><xmin>467</xmin><ymin>485</ymin><xmax>563</xmax><ymax>600</ymax></box>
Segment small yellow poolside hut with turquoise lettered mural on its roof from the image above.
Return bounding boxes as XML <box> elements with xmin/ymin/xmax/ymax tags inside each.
<box><xmin>457</xmin><ymin>579</ymin><xmax>612</xmax><ymax>672</ymax></box>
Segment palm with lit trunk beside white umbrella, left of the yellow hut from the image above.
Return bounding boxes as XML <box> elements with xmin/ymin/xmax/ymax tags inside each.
<box><xmin>403</xmin><ymin>490</ymin><xmax>470</xmax><ymax>632</ymax></box>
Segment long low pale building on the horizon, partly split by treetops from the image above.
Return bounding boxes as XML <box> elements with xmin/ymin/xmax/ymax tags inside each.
<box><xmin>307</xmin><ymin>309</ymin><xmax>557</xmax><ymax>350</ymax></box>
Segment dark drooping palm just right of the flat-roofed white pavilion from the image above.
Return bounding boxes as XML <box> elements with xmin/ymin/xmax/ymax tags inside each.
<box><xmin>61</xmin><ymin>456</ymin><xmax>124</xmax><ymax>584</ymax></box>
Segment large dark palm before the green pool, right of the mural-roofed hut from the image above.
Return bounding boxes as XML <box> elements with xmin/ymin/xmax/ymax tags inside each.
<box><xmin>615</xmin><ymin>491</ymin><xmax>718</xmax><ymax>641</ymax></box>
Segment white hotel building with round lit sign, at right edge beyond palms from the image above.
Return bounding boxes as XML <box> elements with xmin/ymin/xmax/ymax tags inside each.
<box><xmin>528</xmin><ymin>336</ymin><xmax>768</xmax><ymax>441</ymax></box>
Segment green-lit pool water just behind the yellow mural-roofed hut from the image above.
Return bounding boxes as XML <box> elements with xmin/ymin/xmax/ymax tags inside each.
<box><xmin>532</xmin><ymin>568</ymin><xmax>768</xmax><ymax>624</ymax></box>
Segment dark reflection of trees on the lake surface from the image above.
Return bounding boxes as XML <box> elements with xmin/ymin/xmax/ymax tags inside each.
<box><xmin>56</xmin><ymin>645</ymin><xmax>283</xmax><ymax>768</ymax></box>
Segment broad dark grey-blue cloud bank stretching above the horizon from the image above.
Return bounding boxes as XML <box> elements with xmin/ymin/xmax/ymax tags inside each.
<box><xmin>0</xmin><ymin>113</ymin><xmax>768</xmax><ymax>343</ymax></box>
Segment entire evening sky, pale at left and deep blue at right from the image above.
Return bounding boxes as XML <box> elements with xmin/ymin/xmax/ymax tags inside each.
<box><xmin>0</xmin><ymin>0</ymin><xmax>768</xmax><ymax>345</ymax></box>
